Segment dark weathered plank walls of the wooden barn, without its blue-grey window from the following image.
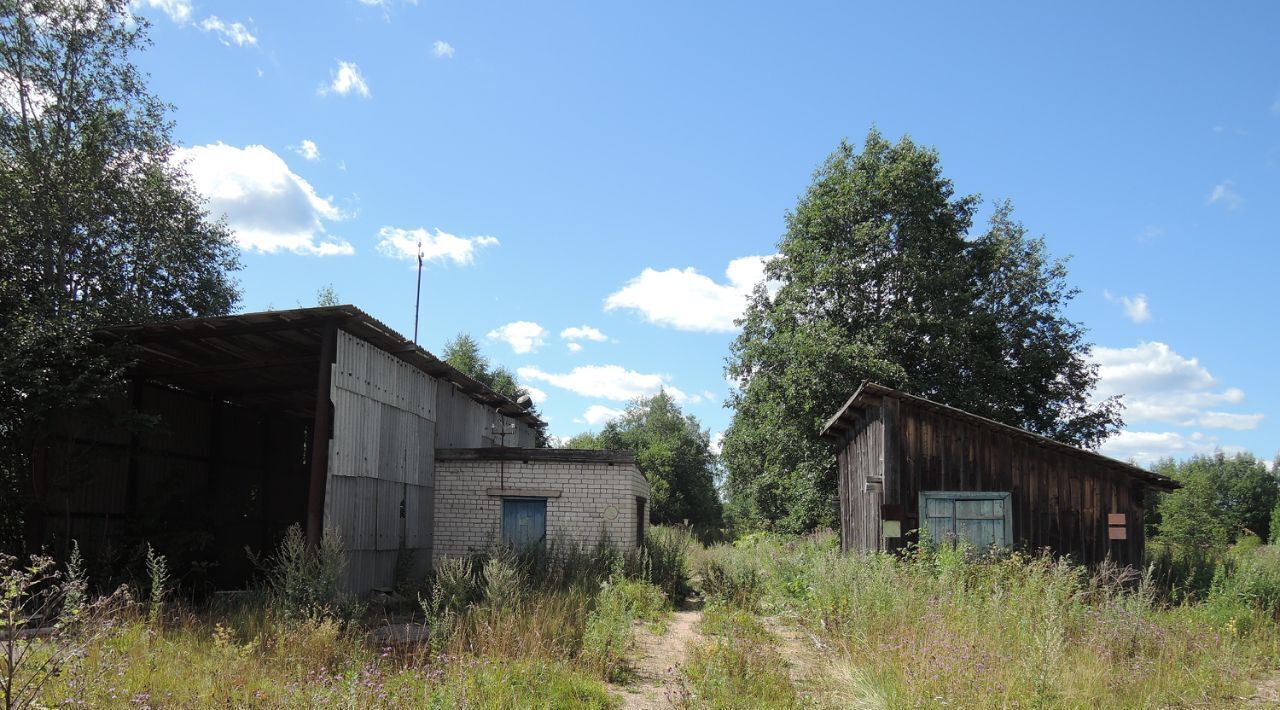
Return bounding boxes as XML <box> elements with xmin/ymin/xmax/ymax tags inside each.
<box><xmin>838</xmin><ymin>397</ymin><xmax>1144</xmax><ymax>564</ymax></box>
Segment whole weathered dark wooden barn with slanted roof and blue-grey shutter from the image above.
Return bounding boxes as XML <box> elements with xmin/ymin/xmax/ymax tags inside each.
<box><xmin>822</xmin><ymin>383</ymin><xmax>1179</xmax><ymax>565</ymax></box>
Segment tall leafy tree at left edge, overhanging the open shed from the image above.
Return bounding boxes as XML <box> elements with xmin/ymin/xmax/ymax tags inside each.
<box><xmin>0</xmin><ymin>0</ymin><xmax>238</xmax><ymax>550</ymax></box>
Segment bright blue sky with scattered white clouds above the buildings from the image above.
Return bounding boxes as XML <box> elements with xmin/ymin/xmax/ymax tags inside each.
<box><xmin>134</xmin><ymin>0</ymin><xmax>1280</xmax><ymax>462</ymax></box>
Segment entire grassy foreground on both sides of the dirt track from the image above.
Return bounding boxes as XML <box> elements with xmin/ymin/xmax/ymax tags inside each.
<box><xmin>17</xmin><ymin>524</ymin><xmax>1280</xmax><ymax>709</ymax></box>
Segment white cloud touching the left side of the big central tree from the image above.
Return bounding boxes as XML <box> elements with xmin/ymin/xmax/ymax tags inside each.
<box><xmin>604</xmin><ymin>256</ymin><xmax>772</xmax><ymax>333</ymax></box>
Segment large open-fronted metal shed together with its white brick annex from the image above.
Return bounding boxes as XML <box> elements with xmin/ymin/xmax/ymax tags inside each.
<box><xmin>28</xmin><ymin>306</ymin><xmax>649</xmax><ymax>592</ymax></box>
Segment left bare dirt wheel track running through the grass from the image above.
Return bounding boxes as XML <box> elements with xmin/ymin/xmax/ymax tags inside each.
<box><xmin>613</xmin><ymin>604</ymin><xmax>703</xmax><ymax>710</ymax></box>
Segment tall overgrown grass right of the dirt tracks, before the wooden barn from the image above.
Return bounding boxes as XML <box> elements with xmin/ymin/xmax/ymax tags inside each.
<box><xmin>701</xmin><ymin>533</ymin><xmax>1280</xmax><ymax>707</ymax></box>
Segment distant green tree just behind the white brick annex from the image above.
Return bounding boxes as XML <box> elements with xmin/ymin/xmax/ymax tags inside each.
<box><xmin>586</xmin><ymin>391</ymin><xmax>722</xmax><ymax>528</ymax></box>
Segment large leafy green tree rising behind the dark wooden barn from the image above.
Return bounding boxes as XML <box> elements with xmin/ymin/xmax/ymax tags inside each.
<box><xmin>723</xmin><ymin>129</ymin><xmax>1120</xmax><ymax>531</ymax></box>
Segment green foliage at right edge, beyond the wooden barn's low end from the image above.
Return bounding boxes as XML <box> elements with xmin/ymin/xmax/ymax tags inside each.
<box><xmin>1153</xmin><ymin>452</ymin><xmax>1280</xmax><ymax>548</ymax></box>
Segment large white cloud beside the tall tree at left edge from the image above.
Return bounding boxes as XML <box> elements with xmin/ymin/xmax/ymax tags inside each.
<box><xmin>174</xmin><ymin>143</ymin><xmax>356</xmax><ymax>256</ymax></box>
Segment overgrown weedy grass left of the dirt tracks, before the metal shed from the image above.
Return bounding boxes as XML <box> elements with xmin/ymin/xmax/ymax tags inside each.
<box><xmin>24</xmin><ymin>537</ymin><xmax>669</xmax><ymax>707</ymax></box>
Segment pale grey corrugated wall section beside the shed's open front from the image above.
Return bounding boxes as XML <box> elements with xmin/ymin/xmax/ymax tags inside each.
<box><xmin>325</xmin><ymin>330</ymin><xmax>438</xmax><ymax>592</ymax></box>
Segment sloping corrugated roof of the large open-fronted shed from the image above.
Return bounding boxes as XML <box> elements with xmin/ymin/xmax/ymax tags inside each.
<box><xmin>97</xmin><ymin>304</ymin><xmax>545</xmax><ymax>426</ymax></box>
